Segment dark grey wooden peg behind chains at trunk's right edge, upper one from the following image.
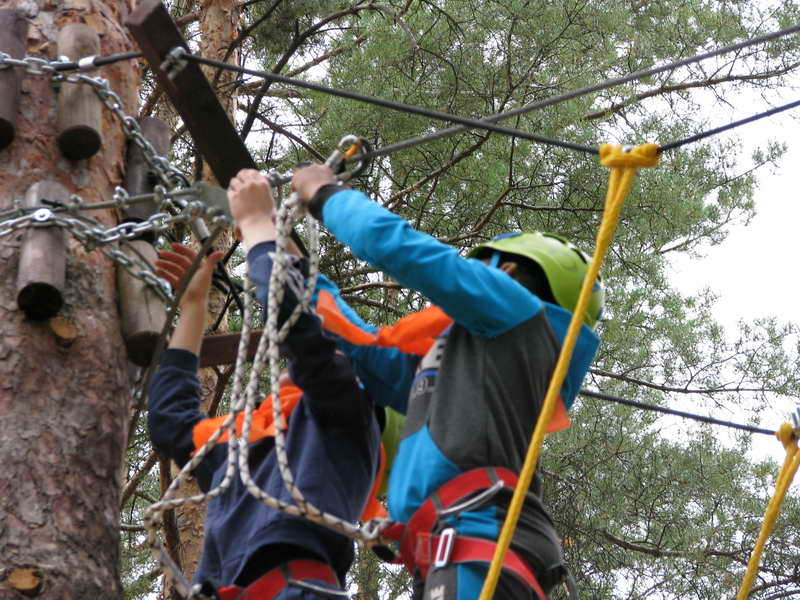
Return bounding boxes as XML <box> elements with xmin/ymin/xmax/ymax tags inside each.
<box><xmin>121</xmin><ymin>117</ymin><xmax>172</xmax><ymax>243</ymax></box>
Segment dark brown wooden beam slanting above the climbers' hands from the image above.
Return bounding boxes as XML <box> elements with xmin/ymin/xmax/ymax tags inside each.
<box><xmin>125</xmin><ymin>0</ymin><xmax>258</xmax><ymax>187</ymax></box>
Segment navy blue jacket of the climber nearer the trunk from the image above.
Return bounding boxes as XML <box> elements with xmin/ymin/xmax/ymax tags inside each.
<box><xmin>148</xmin><ymin>242</ymin><xmax>380</xmax><ymax>585</ymax></box>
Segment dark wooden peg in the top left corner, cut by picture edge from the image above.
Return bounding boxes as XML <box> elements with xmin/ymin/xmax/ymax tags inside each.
<box><xmin>0</xmin><ymin>8</ymin><xmax>28</xmax><ymax>150</ymax></box>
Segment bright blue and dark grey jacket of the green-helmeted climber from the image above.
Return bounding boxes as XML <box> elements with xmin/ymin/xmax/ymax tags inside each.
<box><xmin>322</xmin><ymin>190</ymin><xmax>598</xmax><ymax>580</ymax></box>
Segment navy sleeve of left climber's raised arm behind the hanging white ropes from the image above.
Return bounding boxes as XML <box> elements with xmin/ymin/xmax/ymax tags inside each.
<box><xmin>247</xmin><ymin>242</ymin><xmax>374</xmax><ymax>434</ymax></box>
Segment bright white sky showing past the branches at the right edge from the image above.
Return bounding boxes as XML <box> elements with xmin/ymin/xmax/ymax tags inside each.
<box><xmin>672</xmin><ymin>96</ymin><xmax>800</xmax><ymax>462</ymax></box>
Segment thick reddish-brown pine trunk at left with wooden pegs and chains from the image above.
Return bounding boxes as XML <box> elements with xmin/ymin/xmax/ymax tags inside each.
<box><xmin>0</xmin><ymin>0</ymin><xmax>140</xmax><ymax>600</ymax></box>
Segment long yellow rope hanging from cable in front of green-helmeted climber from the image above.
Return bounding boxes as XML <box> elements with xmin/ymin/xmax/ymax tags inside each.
<box><xmin>480</xmin><ymin>144</ymin><xmax>659</xmax><ymax>600</ymax></box>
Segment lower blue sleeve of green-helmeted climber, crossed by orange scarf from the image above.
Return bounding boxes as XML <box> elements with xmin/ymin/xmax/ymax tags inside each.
<box><xmin>315</xmin><ymin>273</ymin><xmax>419</xmax><ymax>414</ymax></box>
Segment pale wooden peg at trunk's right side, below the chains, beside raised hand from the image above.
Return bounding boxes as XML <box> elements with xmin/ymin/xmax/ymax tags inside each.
<box><xmin>117</xmin><ymin>240</ymin><xmax>167</xmax><ymax>367</ymax></box>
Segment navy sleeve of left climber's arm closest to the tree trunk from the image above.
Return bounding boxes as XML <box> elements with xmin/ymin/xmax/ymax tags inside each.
<box><xmin>147</xmin><ymin>348</ymin><xmax>224</xmax><ymax>491</ymax></box>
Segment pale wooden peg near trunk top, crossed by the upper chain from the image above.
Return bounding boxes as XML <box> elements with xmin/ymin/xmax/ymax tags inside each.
<box><xmin>57</xmin><ymin>23</ymin><xmax>103</xmax><ymax>160</ymax></box>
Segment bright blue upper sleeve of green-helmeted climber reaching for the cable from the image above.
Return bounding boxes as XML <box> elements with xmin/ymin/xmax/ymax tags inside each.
<box><xmin>322</xmin><ymin>190</ymin><xmax>543</xmax><ymax>337</ymax></box>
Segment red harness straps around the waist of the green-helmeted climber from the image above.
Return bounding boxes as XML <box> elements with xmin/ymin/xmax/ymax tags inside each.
<box><xmin>384</xmin><ymin>467</ymin><xmax>547</xmax><ymax>600</ymax></box>
